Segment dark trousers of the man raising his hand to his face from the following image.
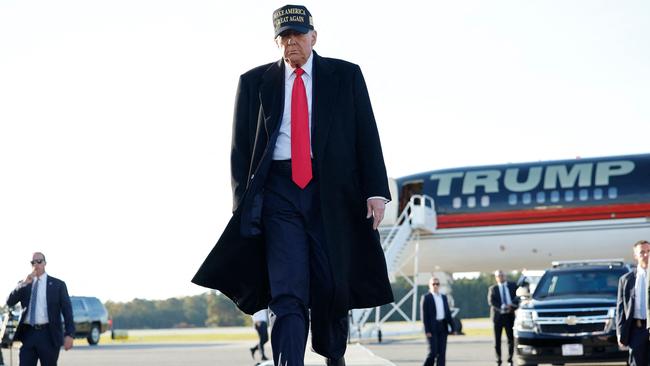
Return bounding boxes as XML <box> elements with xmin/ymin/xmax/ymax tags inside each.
<box><xmin>19</xmin><ymin>325</ymin><xmax>60</xmax><ymax>366</ymax></box>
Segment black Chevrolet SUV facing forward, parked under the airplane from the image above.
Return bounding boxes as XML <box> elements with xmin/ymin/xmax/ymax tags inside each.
<box><xmin>515</xmin><ymin>260</ymin><xmax>631</xmax><ymax>366</ymax></box>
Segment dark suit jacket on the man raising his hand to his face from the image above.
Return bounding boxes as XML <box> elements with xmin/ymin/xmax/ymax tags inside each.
<box><xmin>7</xmin><ymin>274</ymin><xmax>75</xmax><ymax>348</ymax></box>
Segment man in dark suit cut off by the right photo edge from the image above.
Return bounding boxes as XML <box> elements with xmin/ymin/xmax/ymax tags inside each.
<box><xmin>616</xmin><ymin>240</ymin><xmax>650</xmax><ymax>366</ymax></box>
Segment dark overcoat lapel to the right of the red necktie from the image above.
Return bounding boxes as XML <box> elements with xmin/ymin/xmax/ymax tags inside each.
<box><xmin>311</xmin><ymin>52</ymin><xmax>339</xmax><ymax>161</ymax></box>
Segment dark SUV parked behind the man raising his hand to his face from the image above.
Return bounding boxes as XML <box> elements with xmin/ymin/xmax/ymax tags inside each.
<box><xmin>70</xmin><ymin>296</ymin><xmax>111</xmax><ymax>346</ymax></box>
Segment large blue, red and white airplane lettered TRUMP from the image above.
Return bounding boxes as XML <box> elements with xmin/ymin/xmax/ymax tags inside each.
<box><xmin>380</xmin><ymin>154</ymin><xmax>650</xmax><ymax>276</ymax></box>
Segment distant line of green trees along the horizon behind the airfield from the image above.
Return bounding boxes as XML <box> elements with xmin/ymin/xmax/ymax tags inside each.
<box><xmin>105</xmin><ymin>274</ymin><xmax>512</xmax><ymax>329</ymax></box>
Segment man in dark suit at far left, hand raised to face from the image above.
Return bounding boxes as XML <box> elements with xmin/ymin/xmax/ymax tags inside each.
<box><xmin>7</xmin><ymin>252</ymin><xmax>75</xmax><ymax>366</ymax></box>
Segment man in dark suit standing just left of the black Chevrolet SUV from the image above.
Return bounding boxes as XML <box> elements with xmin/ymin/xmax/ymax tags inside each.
<box><xmin>487</xmin><ymin>270</ymin><xmax>519</xmax><ymax>366</ymax></box>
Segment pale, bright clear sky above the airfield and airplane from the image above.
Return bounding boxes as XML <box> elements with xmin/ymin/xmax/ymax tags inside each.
<box><xmin>0</xmin><ymin>0</ymin><xmax>650</xmax><ymax>301</ymax></box>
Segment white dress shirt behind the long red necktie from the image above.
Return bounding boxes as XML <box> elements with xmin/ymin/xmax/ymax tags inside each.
<box><xmin>273</xmin><ymin>52</ymin><xmax>314</xmax><ymax>160</ymax></box>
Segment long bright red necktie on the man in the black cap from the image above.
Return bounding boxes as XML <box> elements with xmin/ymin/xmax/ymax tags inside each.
<box><xmin>291</xmin><ymin>68</ymin><xmax>312</xmax><ymax>188</ymax></box>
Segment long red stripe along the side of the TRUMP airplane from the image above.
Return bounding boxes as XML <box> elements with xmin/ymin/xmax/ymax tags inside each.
<box><xmin>438</xmin><ymin>203</ymin><xmax>650</xmax><ymax>229</ymax></box>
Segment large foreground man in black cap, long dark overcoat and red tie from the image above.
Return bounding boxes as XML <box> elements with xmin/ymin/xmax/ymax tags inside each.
<box><xmin>192</xmin><ymin>5</ymin><xmax>393</xmax><ymax>366</ymax></box>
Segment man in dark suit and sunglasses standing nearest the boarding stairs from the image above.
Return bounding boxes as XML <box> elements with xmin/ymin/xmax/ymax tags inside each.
<box><xmin>421</xmin><ymin>277</ymin><xmax>454</xmax><ymax>366</ymax></box>
